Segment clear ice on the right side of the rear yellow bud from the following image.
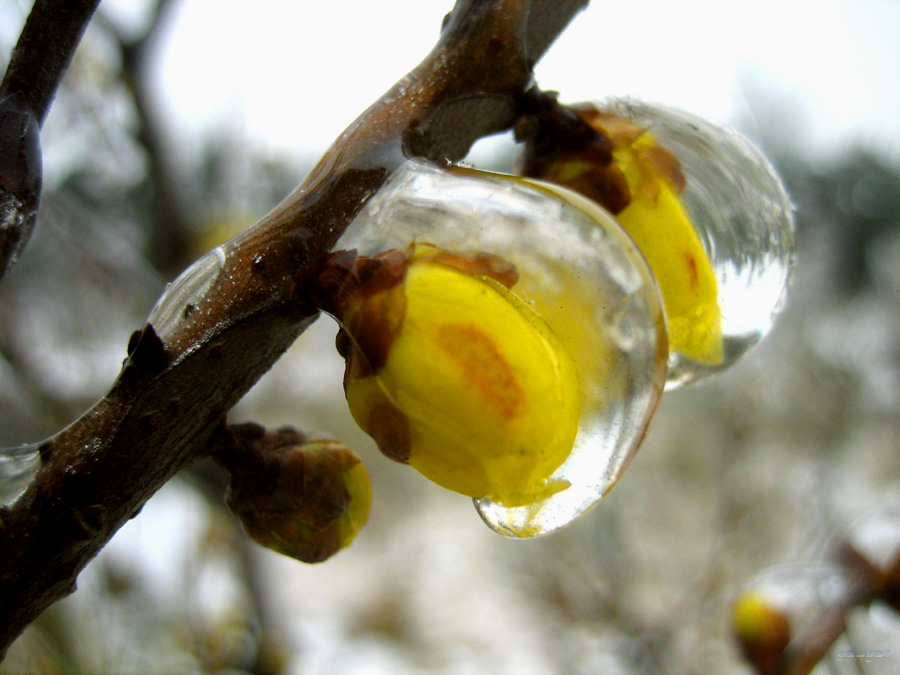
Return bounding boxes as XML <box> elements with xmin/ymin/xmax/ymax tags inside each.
<box><xmin>599</xmin><ymin>101</ymin><xmax>794</xmax><ymax>389</ymax></box>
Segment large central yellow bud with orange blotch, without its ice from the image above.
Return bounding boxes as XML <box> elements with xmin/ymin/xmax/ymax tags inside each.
<box><xmin>344</xmin><ymin>245</ymin><xmax>581</xmax><ymax>506</ymax></box>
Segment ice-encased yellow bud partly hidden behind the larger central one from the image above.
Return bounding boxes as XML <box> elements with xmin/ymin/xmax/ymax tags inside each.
<box><xmin>524</xmin><ymin>101</ymin><xmax>794</xmax><ymax>388</ymax></box>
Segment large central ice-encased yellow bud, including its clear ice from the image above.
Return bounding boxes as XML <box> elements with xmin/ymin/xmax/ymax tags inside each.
<box><xmin>312</xmin><ymin>161</ymin><xmax>667</xmax><ymax>537</ymax></box>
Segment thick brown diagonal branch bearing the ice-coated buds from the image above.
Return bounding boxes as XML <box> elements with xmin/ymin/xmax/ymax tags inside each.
<box><xmin>0</xmin><ymin>0</ymin><xmax>586</xmax><ymax>651</ymax></box>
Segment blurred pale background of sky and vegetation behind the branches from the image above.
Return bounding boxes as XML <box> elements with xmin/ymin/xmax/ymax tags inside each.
<box><xmin>0</xmin><ymin>0</ymin><xmax>900</xmax><ymax>675</ymax></box>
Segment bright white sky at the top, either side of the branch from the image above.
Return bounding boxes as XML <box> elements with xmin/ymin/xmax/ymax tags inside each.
<box><xmin>132</xmin><ymin>0</ymin><xmax>900</xmax><ymax>163</ymax></box>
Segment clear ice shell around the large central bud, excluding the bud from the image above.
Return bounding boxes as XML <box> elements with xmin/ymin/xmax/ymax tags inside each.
<box><xmin>336</xmin><ymin>161</ymin><xmax>667</xmax><ymax>537</ymax></box>
